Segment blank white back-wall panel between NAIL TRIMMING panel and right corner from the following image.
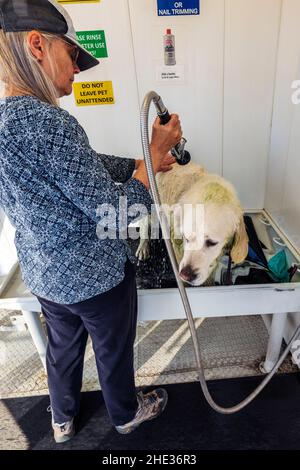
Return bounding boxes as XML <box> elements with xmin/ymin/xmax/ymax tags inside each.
<box><xmin>223</xmin><ymin>0</ymin><xmax>281</xmax><ymax>209</ymax></box>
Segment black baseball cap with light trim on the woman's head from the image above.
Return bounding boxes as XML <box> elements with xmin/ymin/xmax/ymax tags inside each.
<box><xmin>0</xmin><ymin>0</ymin><xmax>99</xmax><ymax>71</ymax></box>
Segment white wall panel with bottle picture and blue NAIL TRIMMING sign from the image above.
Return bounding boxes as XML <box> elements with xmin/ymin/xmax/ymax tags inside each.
<box><xmin>129</xmin><ymin>0</ymin><xmax>224</xmax><ymax>173</ymax></box>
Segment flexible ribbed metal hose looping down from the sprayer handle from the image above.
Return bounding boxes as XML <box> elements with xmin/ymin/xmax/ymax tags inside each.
<box><xmin>141</xmin><ymin>91</ymin><xmax>300</xmax><ymax>414</ymax></box>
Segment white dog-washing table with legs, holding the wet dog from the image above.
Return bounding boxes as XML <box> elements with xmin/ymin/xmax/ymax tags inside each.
<box><xmin>0</xmin><ymin>211</ymin><xmax>300</xmax><ymax>372</ymax></box>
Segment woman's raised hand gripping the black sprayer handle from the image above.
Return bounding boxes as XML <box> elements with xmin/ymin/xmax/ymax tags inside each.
<box><xmin>150</xmin><ymin>114</ymin><xmax>182</xmax><ymax>172</ymax></box>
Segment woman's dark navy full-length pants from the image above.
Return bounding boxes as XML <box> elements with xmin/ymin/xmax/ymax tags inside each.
<box><xmin>37</xmin><ymin>261</ymin><xmax>137</xmax><ymax>426</ymax></box>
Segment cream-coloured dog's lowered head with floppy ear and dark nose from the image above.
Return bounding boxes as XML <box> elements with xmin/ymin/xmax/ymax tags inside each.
<box><xmin>171</xmin><ymin>180</ymin><xmax>248</xmax><ymax>286</ymax></box>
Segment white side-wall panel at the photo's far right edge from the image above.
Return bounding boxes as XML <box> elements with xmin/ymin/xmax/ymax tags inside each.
<box><xmin>266</xmin><ymin>0</ymin><xmax>300</xmax><ymax>250</ymax></box>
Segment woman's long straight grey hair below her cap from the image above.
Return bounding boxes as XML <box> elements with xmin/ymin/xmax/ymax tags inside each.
<box><xmin>0</xmin><ymin>30</ymin><xmax>58</xmax><ymax>106</ymax></box>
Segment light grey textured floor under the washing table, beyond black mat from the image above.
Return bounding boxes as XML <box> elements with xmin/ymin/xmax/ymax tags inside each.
<box><xmin>0</xmin><ymin>310</ymin><xmax>298</xmax><ymax>449</ymax></box>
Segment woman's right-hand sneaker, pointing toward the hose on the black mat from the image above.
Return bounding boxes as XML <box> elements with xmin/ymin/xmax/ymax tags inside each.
<box><xmin>116</xmin><ymin>388</ymin><xmax>168</xmax><ymax>434</ymax></box>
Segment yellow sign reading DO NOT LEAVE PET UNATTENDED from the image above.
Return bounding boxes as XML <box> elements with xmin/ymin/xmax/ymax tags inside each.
<box><xmin>73</xmin><ymin>81</ymin><xmax>115</xmax><ymax>106</ymax></box>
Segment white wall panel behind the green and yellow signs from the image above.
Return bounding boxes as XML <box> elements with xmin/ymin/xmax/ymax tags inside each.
<box><xmin>61</xmin><ymin>0</ymin><xmax>140</xmax><ymax>157</ymax></box>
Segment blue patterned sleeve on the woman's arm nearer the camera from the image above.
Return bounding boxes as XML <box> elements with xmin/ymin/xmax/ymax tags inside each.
<box><xmin>45</xmin><ymin>108</ymin><xmax>152</xmax><ymax>232</ymax></box>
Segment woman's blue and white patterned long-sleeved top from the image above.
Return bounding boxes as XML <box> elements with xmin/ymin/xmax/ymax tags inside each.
<box><xmin>0</xmin><ymin>96</ymin><xmax>152</xmax><ymax>304</ymax></box>
